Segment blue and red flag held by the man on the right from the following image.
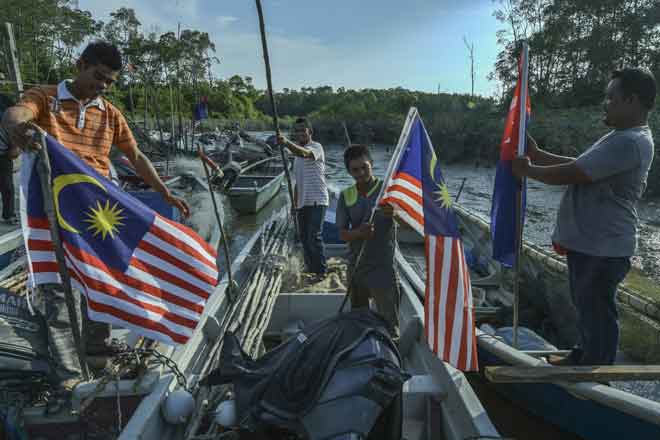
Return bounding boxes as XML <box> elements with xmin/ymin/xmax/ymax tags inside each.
<box><xmin>490</xmin><ymin>44</ymin><xmax>531</xmax><ymax>267</ymax></box>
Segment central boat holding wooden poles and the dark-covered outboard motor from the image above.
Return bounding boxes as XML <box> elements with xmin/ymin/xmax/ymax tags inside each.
<box><xmin>114</xmin><ymin>205</ymin><xmax>500</xmax><ymax>440</ymax></box>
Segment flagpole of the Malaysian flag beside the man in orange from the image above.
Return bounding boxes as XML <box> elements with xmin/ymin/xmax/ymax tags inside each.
<box><xmin>37</xmin><ymin>130</ymin><xmax>89</xmax><ymax>381</ymax></box>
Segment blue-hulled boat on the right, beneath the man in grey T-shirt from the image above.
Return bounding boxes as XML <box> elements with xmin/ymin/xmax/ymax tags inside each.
<box><xmin>401</xmin><ymin>201</ymin><xmax>660</xmax><ymax>440</ymax></box>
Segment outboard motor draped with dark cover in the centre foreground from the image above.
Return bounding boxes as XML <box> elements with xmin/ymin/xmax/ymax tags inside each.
<box><xmin>202</xmin><ymin>309</ymin><xmax>410</xmax><ymax>440</ymax></box>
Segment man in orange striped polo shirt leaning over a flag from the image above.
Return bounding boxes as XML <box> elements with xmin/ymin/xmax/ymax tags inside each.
<box><xmin>2</xmin><ymin>41</ymin><xmax>190</xmax><ymax>381</ymax></box>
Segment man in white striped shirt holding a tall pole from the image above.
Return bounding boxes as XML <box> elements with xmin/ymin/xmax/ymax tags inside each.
<box><xmin>277</xmin><ymin>118</ymin><xmax>329</xmax><ymax>276</ymax></box>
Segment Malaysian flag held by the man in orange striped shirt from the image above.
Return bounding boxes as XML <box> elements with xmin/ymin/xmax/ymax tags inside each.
<box><xmin>21</xmin><ymin>137</ymin><xmax>218</xmax><ymax>344</ymax></box>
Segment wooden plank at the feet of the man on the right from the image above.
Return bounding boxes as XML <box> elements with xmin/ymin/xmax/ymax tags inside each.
<box><xmin>486</xmin><ymin>365</ymin><xmax>660</xmax><ymax>383</ymax></box>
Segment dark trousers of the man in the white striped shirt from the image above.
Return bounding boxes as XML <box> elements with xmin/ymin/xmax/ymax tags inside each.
<box><xmin>296</xmin><ymin>206</ymin><xmax>327</xmax><ymax>274</ymax></box>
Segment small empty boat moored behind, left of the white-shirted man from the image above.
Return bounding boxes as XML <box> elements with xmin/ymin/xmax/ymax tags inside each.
<box><xmin>228</xmin><ymin>156</ymin><xmax>284</xmax><ymax>214</ymax></box>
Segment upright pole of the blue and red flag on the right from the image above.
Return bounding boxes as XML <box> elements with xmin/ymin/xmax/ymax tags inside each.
<box><xmin>513</xmin><ymin>41</ymin><xmax>529</xmax><ymax>348</ymax></box>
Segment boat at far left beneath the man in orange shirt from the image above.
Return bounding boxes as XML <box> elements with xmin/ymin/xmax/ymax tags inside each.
<box><xmin>0</xmin><ymin>169</ymin><xmax>229</xmax><ymax>440</ymax></box>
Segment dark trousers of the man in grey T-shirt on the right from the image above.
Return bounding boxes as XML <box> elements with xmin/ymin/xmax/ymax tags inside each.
<box><xmin>567</xmin><ymin>251</ymin><xmax>630</xmax><ymax>365</ymax></box>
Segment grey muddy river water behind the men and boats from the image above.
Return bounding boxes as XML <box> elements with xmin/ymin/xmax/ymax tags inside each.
<box><xmin>215</xmin><ymin>144</ymin><xmax>660</xmax><ymax>281</ymax></box>
